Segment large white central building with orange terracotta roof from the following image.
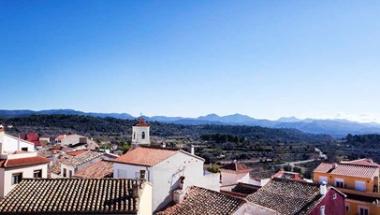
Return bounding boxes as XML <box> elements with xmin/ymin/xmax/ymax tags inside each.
<box><xmin>113</xmin><ymin>147</ymin><xmax>220</xmax><ymax>211</ymax></box>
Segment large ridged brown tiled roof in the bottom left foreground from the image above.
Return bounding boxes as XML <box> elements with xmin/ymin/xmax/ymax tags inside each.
<box><xmin>0</xmin><ymin>179</ymin><xmax>138</xmax><ymax>214</ymax></box>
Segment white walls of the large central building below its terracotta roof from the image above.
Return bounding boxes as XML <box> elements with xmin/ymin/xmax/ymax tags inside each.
<box><xmin>113</xmin><ymin>151</ymin><xmax>220</xmax><ymax>211</ymax></box>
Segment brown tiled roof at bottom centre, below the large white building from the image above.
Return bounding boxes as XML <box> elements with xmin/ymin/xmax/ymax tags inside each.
<box><xmin>158</xmin><ymin>187</ymin><xmax>245</xmax><ymax>215</ymax></box>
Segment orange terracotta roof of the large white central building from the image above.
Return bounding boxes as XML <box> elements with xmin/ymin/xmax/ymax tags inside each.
<box><xmin>115</xmin><ymin>147</ymin><xmax>178</xmax><ymax>166</ymax></box>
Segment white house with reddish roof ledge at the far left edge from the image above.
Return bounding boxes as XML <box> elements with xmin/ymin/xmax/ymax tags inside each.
<box><xmin>0</xmin><ymin>126</ymin><xmax>49</xmax><ymax>198</ymax></box>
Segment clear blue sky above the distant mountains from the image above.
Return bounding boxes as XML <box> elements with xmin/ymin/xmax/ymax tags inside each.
<box><xmin>0</xmin><ymin>0</ymin><xmax>380</xmax><ymax>122</ymax></box>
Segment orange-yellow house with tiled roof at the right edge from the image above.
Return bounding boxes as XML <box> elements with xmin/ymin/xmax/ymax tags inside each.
<box><xmin>313</xmin><ymin>158</ymin><xmax>380</xmax><ymax>215</ymax></box>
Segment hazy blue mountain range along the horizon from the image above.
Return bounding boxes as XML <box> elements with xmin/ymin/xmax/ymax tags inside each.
<box><xmin>0</xmin><ymin>109</ymin><xmax>380</xmax><ymax>137</ymax></box>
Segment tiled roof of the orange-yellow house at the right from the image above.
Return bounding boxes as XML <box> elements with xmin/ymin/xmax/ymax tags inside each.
<box><xmin>314</xmin><ymin>163</ymin><xmax>379</xmax><ymax>178</ymax></box>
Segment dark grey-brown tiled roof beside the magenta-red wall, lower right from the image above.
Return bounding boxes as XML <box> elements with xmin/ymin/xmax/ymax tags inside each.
<box><xmin>247</xmin><ymin>178</ymin><xmax>320</xmax><ymax>215</ymax></box>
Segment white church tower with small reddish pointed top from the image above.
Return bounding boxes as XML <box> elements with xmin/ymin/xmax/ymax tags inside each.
<box><xmin>132</xmin><ymin>117</ymin><xmax>150</xmax><ymax>146</ymax></box>
